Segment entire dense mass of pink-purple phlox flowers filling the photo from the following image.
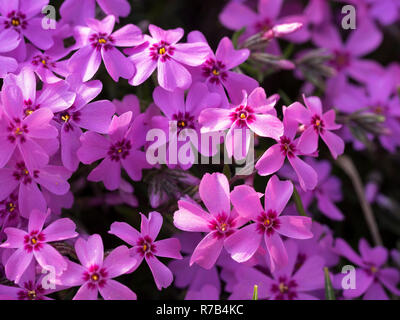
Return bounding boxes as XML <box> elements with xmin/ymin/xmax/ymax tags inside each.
<box><xmin>0</xmin><ymin>0</ymin><xmax>400</xmax><ymax>300</ymax></box>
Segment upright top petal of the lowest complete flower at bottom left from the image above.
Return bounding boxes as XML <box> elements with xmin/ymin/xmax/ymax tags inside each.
<box><xmin>75</xmin><ymin>234</ymin><xmax>104</xmax><ymax>268</ymax></box>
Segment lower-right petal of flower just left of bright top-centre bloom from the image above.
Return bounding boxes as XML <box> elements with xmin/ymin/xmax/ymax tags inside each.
<box><xmin>101</xmin><ymin>47</ymin><xmax>135</xmax><ymax>82</ymax></box>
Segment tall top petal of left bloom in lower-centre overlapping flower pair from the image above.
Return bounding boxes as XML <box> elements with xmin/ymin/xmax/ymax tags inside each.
<box><xmin>199</xmin><ymin>173</ymin><xmax>231</xmax><ymax>215</ymax></box>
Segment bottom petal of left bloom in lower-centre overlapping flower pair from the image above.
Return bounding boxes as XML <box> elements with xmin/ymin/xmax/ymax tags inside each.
<box><xmin>190</xmin><ymin>232</ymin><xmax>224</xmax><ymax>269</ymax></box>
